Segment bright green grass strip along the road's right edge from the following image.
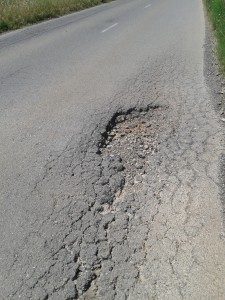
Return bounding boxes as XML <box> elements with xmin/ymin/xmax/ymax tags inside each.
<box><xmin>205</xmin><ymin>0</ymin><xmax>225</xmax><ymax>75</ymax></box>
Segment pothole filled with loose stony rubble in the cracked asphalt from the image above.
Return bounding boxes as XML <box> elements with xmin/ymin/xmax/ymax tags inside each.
<box><xmin>100</xmin><ymin>107</ymin><xmax>165</xmax><ymax>193</ymax></box>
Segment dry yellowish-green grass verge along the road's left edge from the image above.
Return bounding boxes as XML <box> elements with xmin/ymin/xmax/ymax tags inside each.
<box><xmin>0</xmin><ymin>0</ymin><xmax>110</xmax><ymax>33</ymax></box>
